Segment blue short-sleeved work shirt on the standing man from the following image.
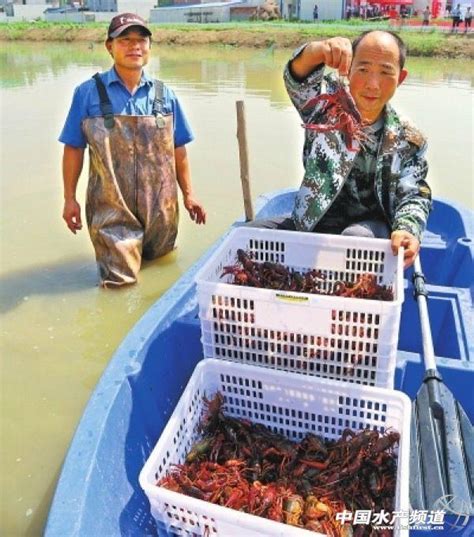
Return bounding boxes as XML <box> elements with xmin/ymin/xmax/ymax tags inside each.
<box><xmin>59</xmin><ymin>67</ymin><xmax>194</xmax><ymax>151</ymax></box>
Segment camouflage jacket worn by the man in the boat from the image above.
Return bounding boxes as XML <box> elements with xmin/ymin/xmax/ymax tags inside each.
<box><xmin>284</xmin><ymin>58</ymin><xmax>431</xmax><ymax>239</ymax></box>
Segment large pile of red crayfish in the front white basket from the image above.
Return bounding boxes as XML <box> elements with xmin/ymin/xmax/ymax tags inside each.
<box><xmin>157</xmin><ymin>393</ymin><xmax>400</xmax><ymax>537</ymax></box>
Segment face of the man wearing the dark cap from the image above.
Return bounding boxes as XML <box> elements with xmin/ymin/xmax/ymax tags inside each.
<box><xmin>106</xmin><ymin>27</ymin><xmax>150</xmax><ymax>70</ymax></box>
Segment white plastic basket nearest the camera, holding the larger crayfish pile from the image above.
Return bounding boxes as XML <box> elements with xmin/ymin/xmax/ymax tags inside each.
<box><xmin>140</xmin><ymin>359</ymin><xmax>411</xmax><ymax>537</ymax></box>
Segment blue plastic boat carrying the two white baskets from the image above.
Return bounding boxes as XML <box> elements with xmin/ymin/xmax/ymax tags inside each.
<box><xmin>45</xmin><ymin>189</ymin><xmax>474</xmax><ymax>537</ymax></box>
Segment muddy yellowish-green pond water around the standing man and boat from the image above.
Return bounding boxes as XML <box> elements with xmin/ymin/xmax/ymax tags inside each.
<box><xmin>0</xmin><ymin>43</ymin><xmax>474</xmax><ymax>537</ymax></box>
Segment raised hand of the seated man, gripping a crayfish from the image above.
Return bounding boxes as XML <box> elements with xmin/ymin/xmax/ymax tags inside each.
<box><xmin>291</xmin><ymin>37</ymin><xmax>352</xmax><ymax>79</ymax></box>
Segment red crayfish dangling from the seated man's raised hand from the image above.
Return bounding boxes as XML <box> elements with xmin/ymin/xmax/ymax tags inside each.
<box><xmin>303</xmin><ymin>78</ymin><xmax>369</xmax><ymax>151</ymax></box>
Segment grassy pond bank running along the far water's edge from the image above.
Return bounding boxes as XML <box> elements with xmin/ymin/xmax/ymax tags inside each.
<box><xmin>0</xmin><ymin>22</ymin><xmax>474</xmax><ymax>59</ymax></box>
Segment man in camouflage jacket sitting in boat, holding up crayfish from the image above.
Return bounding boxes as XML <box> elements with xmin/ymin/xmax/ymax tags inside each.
<box><xmin>248</xmin><ymin>30</ymin><xmax>431</xmax><ymax>267</ymax></box>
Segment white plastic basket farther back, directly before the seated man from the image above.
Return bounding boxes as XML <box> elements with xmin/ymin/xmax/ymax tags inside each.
<box><xmin>196</xmin><ymin>227</ymin><xmax>404</xmax><ymax>388</ymax></box>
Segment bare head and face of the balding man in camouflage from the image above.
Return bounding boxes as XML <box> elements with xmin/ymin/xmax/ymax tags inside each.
<box><xmin>349</xmin><ymin>32</ymin><xmax>407</xmax><ymax>123</ymax></box>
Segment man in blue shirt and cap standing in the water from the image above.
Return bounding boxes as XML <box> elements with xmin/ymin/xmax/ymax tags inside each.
<box><xmin>59</xmin><ymin>13</ymin><xmax>206</xmax><ymax>287</ymax></box>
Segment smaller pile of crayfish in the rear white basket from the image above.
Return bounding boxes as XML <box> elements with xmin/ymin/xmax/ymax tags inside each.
<box><xmin>221</xmin><ymin>249</ymin><xmax>393</xmax><ymax>301</ymax></box>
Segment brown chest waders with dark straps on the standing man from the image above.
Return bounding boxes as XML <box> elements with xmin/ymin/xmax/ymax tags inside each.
<box><xmin>82</xmin><ymin>74</ymin><xmax>178</xmax><ymax>287</ymax></box>
